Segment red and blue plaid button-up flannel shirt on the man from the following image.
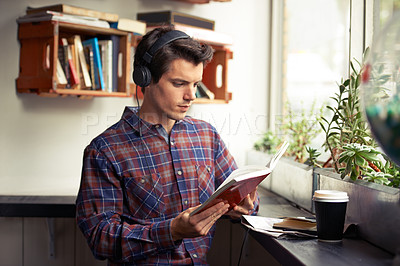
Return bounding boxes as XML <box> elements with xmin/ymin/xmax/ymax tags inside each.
<box><xmin>76</xmin><ymin>108</ymin><xmax>258</xmax><ymax>265</ymax></box>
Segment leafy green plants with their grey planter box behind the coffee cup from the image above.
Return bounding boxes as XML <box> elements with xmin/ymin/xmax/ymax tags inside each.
<box><xmin>314</xmin><ymin>48</ymin><xmax>400</xmax><ymax>253</ymax></box>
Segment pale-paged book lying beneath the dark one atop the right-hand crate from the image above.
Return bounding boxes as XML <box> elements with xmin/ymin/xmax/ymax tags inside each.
<box><xmin>147</xmin><ymin>23</ymin><xmax>233</xmax><ymax>46</ymax></box>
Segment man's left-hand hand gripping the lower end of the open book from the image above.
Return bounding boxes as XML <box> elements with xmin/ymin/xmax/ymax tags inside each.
<box><xmin>171</xmin><ymin>202</ymin><xmax>229</xmax><ymax>241</ymax></box>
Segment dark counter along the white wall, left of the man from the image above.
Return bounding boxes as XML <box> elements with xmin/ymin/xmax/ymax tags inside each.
<box><xmin>0</xmin><ymin>196</ymin><xmax>76</xmax><ymax>218</ymax></box>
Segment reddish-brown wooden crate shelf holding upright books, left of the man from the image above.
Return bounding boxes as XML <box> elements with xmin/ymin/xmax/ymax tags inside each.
<box><xmin>16</xmin><ymin>21</ymin><xmax>136</xmax><ymax>97</ymax></box>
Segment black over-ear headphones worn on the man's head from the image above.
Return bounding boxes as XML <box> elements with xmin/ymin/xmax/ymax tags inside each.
<box><xmin>132</xmin><ymin>30</ymin><xmax>189</xmax><ymax>88</ymax></box>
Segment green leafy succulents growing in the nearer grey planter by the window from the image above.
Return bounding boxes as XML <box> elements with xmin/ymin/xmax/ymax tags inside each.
<box><xmin>320</xmin><ymin>48</ymin><xmax>400</xmax><ymax>188</ymax></box>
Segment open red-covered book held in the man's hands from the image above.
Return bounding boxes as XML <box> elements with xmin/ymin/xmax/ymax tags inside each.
<box><xmin>190</xmin><ymin>141</ymin><xmax>289</xmax><ymax>216</ymax></box>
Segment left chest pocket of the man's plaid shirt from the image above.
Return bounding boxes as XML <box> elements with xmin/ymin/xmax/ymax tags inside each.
<box><xmin>123</xmin><ymin>173</ymin><xmax>165</xmax><ymax>219</ymax></box>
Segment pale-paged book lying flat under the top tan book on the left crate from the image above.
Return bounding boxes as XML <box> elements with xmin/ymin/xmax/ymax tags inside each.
<box><xmin>17</xmin><ymin>10</ymin><xmax>110</xmax><ymax>28</ymax></box>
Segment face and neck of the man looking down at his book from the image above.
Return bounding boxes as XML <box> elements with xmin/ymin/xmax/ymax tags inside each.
<box><xmin>142</xmin><ymin>59</ymin><xmax>203</xmax><ymax>127</ymax></box>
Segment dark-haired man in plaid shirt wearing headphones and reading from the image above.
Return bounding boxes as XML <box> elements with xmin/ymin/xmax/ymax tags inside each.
<box><xmin>76</xmin><ymin>24</ymin><xmax>258</xmax><ymax>265</ymax></box>
